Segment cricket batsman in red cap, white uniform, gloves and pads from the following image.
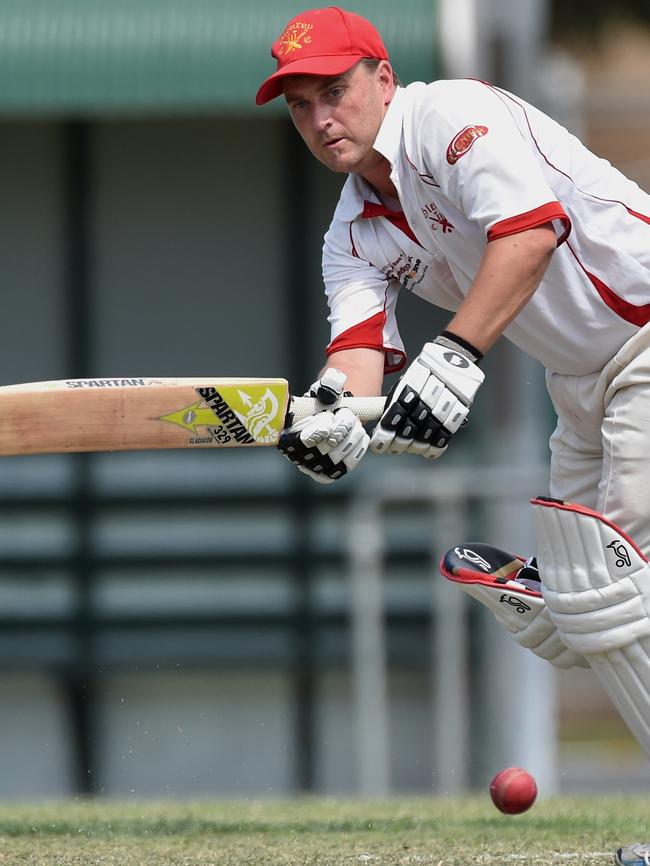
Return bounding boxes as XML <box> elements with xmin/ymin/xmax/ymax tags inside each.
<box><xmin>257</xmin><ymin>6</ymin><xmax>650</xmax><ymax>866</ymax></box>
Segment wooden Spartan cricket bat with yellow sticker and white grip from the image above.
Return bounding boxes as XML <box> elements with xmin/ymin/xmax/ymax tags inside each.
<box><xmin>0</xmin><ymin>378</ymin><xmax>385</xmax><ymax>456</ymax></box>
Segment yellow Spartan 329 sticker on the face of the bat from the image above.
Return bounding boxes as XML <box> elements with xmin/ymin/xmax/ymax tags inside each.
<box><xmin>160</xmin><ymin>384</ymin><xmax>286</xmax><ymax>445</ymax></box>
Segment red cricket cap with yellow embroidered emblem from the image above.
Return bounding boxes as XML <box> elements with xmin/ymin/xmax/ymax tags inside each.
<box><xmin>255</xmin><ymin>6</ymin><xmax>388</xmax><ymax>105</ymax></box>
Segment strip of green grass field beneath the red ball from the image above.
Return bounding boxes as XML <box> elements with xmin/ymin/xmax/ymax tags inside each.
<box><xmin>0</xmin><ymin>795</ymin><xmax>650</xmax><ymax>866</ymax></box>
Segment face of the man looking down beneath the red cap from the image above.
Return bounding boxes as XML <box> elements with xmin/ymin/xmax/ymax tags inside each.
<box><xmin>284</xmin><ymin>61</ymin><xmax>395</xmax><ymax>174</ymax></box>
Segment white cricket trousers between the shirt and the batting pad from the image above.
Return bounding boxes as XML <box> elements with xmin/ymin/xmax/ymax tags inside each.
<box><xmin>546</xmin><ymin>325</ymin><xmax>650</xmax><ymax>556</ymax></box>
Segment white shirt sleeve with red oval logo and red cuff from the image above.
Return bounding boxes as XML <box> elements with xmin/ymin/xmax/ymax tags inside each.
<box><xmin>411</xmin><ymin>80</ymin><xmax>571</xmax><ymax>245</ymax></box>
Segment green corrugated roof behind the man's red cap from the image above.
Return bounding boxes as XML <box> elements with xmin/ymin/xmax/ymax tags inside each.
<box><xmin>0</xmin><ymin>0</ymin><xmax>435</xmax><ymax>116</ymax></box>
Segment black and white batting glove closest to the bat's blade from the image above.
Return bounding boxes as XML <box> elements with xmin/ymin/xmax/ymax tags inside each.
<box><xmin>278</xmin><ymin>368</ymin><xmax>370</xmax><ymax>484</ymax></box>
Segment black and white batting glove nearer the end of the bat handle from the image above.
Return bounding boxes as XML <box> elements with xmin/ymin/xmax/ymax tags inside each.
<box><xmin>370</xmin><ymin>337</ymin><xmax>485</xmax><ymax>458</ymax></box>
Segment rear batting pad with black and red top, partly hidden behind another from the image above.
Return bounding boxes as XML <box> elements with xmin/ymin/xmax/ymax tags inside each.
<box><xmin>440</xmin><ymin>542</ymin><xmax>589</xmax><ymax>668</ymax></box>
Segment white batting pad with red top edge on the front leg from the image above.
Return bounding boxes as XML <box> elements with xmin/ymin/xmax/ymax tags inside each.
<box><xmin>532</xmin><ymin>499</ymin><xmax>650</xmax><ymax>754</ymax></box>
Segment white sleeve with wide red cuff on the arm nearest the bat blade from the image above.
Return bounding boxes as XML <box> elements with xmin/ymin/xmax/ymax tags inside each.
<box><xmin>323</xmin><ymin>214</ymin><xmax>406</xmax><ymax>373</ymax></box>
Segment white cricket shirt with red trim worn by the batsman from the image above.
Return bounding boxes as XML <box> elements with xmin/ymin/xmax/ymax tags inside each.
<box><xmin>323</xmin><ymin>80</ymin><xmax>650</xmax><ymax>375</ymax></box>
